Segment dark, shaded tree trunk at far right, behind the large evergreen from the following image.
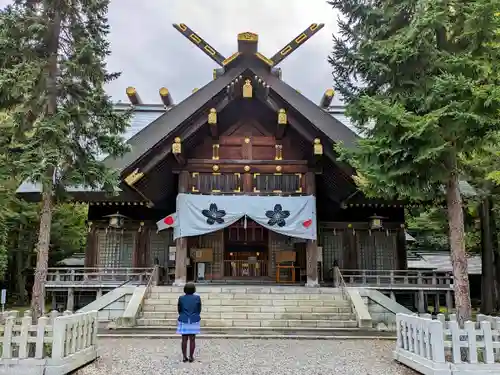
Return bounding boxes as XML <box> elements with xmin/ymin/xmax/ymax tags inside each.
<box><xmin>480</xmin><ymin>198</ymin><xmax>495</xmax><ymax>315</ymax></box>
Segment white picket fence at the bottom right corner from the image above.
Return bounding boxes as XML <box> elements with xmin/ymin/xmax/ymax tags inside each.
<box><xmin>394</xmin><ymin>314</ymin><xmax>500</xmax><ymax>375</ymax></box>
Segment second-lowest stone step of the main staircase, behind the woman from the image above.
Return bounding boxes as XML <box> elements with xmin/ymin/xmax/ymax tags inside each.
<box><xmin>142</xmin><ymin>311</ymin><xmax>355</xmax><ymax>320</ymax></box>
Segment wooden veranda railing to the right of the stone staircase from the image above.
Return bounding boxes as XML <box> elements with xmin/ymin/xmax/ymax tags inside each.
<box><xmin>341</xmin><ymin>270</ymin><xmax>453</xmax><ymax>290</ymax></box>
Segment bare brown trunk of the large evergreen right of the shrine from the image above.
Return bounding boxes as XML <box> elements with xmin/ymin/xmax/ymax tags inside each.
<box><xmin>446</xmin><ymin>164</ymin><xmax>472</xmax><ymax>327</ymax></box>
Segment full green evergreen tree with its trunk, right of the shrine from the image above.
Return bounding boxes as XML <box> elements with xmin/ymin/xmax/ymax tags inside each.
<box><xmin>329</xmin><ymin>0</ymin><xmax>500</xmax><ymax>323</ymax></box>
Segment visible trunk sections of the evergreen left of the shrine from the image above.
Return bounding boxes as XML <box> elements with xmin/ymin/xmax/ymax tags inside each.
<box><xmin>31</xmin><ymin>2</ymin><xmax>62</xmax><ymax>323</ymax></box>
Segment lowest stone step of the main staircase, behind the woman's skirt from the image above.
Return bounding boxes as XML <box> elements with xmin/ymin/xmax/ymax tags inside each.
<box><xmin>137</xmin><ymin>318</ymin><xmax>358</xmax><ymax>329</ymax></box>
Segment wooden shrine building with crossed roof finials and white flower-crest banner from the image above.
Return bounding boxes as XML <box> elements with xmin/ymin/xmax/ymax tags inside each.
<box><xmin>18</xmin><ymin>24</ymin><xmax>407</xmax><ymax>286</ymax></box>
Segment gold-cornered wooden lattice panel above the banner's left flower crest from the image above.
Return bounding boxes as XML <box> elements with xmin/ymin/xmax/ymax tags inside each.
<box><xmin>191</xmin><ymin>172</ymin><xmax>241</xmax><ymax>193</ymax></box>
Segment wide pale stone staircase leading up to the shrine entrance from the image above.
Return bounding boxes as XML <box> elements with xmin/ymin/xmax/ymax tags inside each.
<box><xmin>136</xmin><ymin>285</ymin><xmax>358</xmax><ymax>335</ymax></box>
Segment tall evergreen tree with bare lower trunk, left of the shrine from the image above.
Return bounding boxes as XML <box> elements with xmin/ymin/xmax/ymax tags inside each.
<box><xmin>0</xmin><ymin>0</ymin><xmax>129</xmax><ymax>319</ymax></box>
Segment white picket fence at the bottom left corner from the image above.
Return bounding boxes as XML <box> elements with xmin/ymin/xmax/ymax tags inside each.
<box><xmin>0</xmin><ymin>311</ymin><xmax>98</xmax><ymax>375</ymax></box>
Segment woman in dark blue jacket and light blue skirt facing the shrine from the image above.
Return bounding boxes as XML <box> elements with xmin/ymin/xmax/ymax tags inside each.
<box><xmin>177</xmin><ymin>283</ymin><xmax>201</xmax><ymax>362</ymax></box>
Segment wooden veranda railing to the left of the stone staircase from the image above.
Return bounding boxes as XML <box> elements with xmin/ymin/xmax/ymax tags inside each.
<box><xmin>47</xmin><ymin>267</ymin><xmax>153</xmax><ymax>285</ymax></box>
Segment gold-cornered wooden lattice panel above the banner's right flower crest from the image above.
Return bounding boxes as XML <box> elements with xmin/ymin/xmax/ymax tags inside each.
<box><xmin>253</xmin><ymin>173</ymin><xmax>302</xmax><ymax>193</ymax></box>
